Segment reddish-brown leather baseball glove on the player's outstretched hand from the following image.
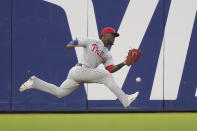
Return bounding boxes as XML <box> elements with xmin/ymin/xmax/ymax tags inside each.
<box><xmin>125</xmin><ymin>49</ymin><xmax>142</xmax><ymax>66</ymax></box>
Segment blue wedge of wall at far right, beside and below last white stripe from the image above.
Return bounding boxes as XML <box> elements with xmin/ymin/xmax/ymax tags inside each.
<box><xmin>164</xmin><ymin>13</ymin><xmax>197</xmax><ymax>111</ymax></box>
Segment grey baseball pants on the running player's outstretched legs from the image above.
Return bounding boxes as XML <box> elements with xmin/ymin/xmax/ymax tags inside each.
<box><xmin>32</xmin><ymin>65</ymin><xmax>128</xmax><ymax>107</ymax></box>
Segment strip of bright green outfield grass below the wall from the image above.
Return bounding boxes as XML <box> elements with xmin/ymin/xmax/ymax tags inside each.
<box><xmin>0</xmin><ymin>113</ymin><xmax>197</xmax><ymax>131</ymax></box>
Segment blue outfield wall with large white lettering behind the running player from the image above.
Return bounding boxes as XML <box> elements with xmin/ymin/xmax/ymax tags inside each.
<box><xmin>0</xmin><ymin>0</ymin><xmax>197</xmax><ymax>111</ymax></box>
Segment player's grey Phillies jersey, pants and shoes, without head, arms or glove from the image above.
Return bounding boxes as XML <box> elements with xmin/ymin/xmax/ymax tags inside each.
<box><xmin>19</xmin><ymin>39</ymin><xmax>138</xmax><ymax>108</ymax></box>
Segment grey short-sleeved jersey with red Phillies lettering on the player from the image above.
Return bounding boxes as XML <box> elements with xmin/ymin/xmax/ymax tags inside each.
<box><xmin>78</xmin><ymin>38</ymin><xmax>113</xmax><ymax>68</ymax></box>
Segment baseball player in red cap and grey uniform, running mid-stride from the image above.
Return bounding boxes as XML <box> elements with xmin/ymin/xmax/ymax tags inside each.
<box><xmin>19</xmin><ymin>27</ymin><xmax>141</xmax><ymax>108</ymax></box>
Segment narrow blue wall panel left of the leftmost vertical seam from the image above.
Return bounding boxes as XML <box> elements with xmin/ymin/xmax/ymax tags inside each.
<box><xmin>0</xmin><ymin>0</ymin><xmax>11</xmax><ymax>111</ymax></box>
